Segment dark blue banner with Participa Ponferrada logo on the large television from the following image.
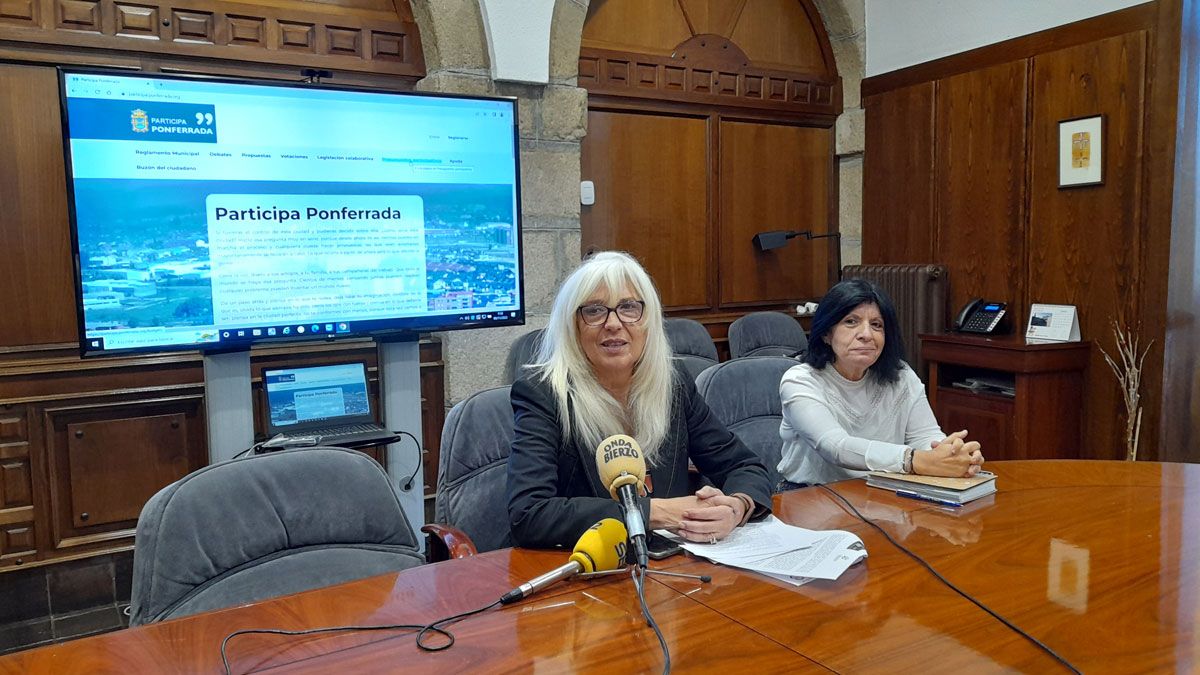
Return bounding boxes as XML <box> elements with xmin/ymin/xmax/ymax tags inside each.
<box><xmin>67</xmin><ymin>98</ymin><xmax>217</xmax><ymax>143</ymax></box>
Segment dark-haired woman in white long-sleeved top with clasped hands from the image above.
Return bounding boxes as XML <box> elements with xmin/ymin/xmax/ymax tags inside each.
<box><xmin>779</xmin><ymin>279</ymin><xmax>983</xmax><ymax>489</ymax></box>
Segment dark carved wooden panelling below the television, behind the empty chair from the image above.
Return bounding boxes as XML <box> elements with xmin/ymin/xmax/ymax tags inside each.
<box><xmin>0</xmin><ymin>339</ymin><xmax>445</xmax><ymax>572</ymax></box>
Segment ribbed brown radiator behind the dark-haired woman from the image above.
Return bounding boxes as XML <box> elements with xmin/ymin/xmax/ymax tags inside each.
<box><xmin>841</xmin><ymin>264</ymin><xmax>949</xmax><ymax>382</ymax></box>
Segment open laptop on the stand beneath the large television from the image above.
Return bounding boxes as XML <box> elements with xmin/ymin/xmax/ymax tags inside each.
<box><xmin>263</xmin><ymin>363</ymin><xmax>396</xmax><ymax>447</ymax></box>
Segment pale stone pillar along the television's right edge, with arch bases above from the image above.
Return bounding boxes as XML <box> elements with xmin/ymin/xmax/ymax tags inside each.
<box><xmin>413</xmin><ymin>0</ymin><xmax>587</xmax><ymax>407</ymax></box>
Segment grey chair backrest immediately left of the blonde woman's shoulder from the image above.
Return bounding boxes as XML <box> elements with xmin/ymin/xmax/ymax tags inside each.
<box><xmin>433</xmin><ymin>386</ymin><xmax>512</xmax><ymax>552</ymax></box>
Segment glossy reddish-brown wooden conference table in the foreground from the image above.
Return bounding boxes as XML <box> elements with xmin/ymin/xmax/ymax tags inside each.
<box><xmin>0</xmin><ymin>460</ymin><xmax>1200</xmax><ymax>674</ymax></box>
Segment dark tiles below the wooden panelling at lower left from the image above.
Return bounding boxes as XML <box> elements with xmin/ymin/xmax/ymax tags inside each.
<box><xmin>0</xmin><ymin>552</ymin><xmax>133</xmax><ymax>653</ymax></box>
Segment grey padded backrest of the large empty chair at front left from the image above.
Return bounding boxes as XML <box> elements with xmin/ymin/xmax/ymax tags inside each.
<box><xmin>130</xmin><ymin>447</ymin><xmax>425</xmax><ymax>625</ymax></box>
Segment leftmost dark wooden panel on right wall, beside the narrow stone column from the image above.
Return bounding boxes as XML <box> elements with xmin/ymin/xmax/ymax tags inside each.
<box><xmin>863</xmin><ymin>82</ymin><xmax>941</xmax><ymax>264</ymax></box>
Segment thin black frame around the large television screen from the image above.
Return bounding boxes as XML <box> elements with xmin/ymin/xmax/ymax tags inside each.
<box><xmin>56</xmin><ymin>66</ymin><xmax>527</xmax><ymax>358</ymax></box>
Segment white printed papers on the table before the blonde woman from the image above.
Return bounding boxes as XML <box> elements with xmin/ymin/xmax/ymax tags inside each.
<box><xmin>680</xmin><ymin>516</ymin><xmax>866</xmax><ymax>586</ymax></box>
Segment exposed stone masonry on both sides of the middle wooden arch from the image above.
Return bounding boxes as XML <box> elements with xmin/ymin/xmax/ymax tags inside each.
<box><xmin>413</xmin><ymin>0</ymin><xmax>866</xmax><ymax>407</ymax></box>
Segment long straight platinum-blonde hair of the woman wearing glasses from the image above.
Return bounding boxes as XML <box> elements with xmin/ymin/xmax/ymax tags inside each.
<box><xmin>532</xmin><ymin>251</ymin><xmax>674</xmax><ymax>464</ymax></box>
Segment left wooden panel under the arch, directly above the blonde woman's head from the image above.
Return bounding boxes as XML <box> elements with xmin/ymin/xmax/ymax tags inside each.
<box><xmin>581</xmin><ymin>110</ymin><xmax>710</xmax><ymax>309</ymax></box>
